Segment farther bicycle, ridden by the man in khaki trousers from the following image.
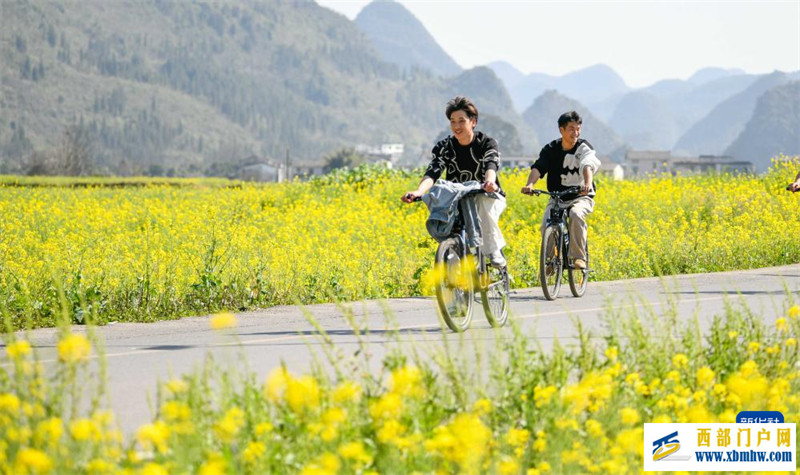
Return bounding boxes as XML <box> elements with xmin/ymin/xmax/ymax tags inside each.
<box><xmin>532</xmin><ymin>186</ymin><xmax>591</xmax><ymax>300</ymax></box>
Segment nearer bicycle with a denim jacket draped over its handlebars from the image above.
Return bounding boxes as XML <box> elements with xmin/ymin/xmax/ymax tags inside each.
<box><xmin>415</xmin><ymin>191</ymin><xmax>510</xmax><ymax>333</ymax></box>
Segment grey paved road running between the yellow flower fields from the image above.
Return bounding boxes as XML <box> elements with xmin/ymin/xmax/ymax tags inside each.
<box><xmin>7</xmin><ymin>264</ymin><xmax>800</xmax><ymax>433</ymax></box>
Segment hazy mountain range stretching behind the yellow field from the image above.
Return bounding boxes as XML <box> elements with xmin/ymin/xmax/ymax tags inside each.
<box><xmin>0</xmin><ymin>0</ymin><xmax>800</xmax><ymax>175</ymax></box>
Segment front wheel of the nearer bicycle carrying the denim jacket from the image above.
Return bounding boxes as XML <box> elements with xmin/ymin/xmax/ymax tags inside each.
<box><xmin>435</xmin><ymin>238</ymin><xmax>475</xmax><ymax>333</ymax></box>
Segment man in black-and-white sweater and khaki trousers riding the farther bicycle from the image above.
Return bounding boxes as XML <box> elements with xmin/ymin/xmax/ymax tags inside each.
<box><xmin>522</xmin><ymin>111</ymin><xmax>600</xmax><ymax>269</ymax></box>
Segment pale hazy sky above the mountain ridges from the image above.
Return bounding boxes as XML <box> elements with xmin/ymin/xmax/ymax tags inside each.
<box><xmin>317</xmin><ymin>0</ymin><xmax>800</xmax><ymax>87</ymax></box>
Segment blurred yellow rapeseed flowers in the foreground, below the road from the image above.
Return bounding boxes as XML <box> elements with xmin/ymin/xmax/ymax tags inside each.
<box><xmin>0</xmin><ymin>296</ymin><xmax>800</xmax><ymax>475</ymax></box>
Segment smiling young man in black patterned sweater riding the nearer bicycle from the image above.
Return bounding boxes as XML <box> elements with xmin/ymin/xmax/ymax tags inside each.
<box><xmin>401</xmin><ymin>96</ymin><xmax>506</xmax><ymax>267</ymax></box>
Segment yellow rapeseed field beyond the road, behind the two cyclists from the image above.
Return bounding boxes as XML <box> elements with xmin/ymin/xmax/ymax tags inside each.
<box><xmin>0</xmin><ymin>157</ymin><xmax>800</xmax><ymax>328</ymax></box>
